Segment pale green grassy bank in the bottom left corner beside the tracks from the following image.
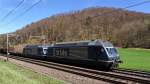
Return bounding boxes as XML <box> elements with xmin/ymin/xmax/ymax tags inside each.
<box><xmin>0</xmin><ymin>61</ymin><xmax>64</xmax><ymax>84</ymax></box>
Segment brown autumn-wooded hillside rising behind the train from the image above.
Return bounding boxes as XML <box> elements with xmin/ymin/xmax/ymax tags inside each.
<box><xmin>0</xmin><ymin>7</ymin><xmax>150</xmax><ymax>48</ymax></box>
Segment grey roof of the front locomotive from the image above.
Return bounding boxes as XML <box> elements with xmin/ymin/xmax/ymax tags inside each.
<box><xmin>52</xmin><ymin>39</ymin><xmax>113</xmax><ymax>47</ymax></box>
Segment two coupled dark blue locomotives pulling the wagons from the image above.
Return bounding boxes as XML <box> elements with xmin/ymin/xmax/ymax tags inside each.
<box><xmin>0</xmin><ymin>40</ymin><xmax>121</xmax><ymax>70</ymax></box>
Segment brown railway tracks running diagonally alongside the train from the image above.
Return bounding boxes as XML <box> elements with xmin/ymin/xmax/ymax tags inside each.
<box><xmin>0</xmin><ymin>55</ymin><xmax>150</xmax><ymax>84</ymax></box>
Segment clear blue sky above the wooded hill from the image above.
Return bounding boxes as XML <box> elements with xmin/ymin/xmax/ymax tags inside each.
<box><xmin>0</xmin><ymin>0</ymin><xmax>150</xmax><ymax>34</ymax></box>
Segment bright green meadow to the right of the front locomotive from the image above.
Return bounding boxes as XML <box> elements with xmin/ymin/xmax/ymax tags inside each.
<box><xmin>118</xmin><ymin>48</ymin><xmax>150</xmax><ymax>71</ymax></box>
